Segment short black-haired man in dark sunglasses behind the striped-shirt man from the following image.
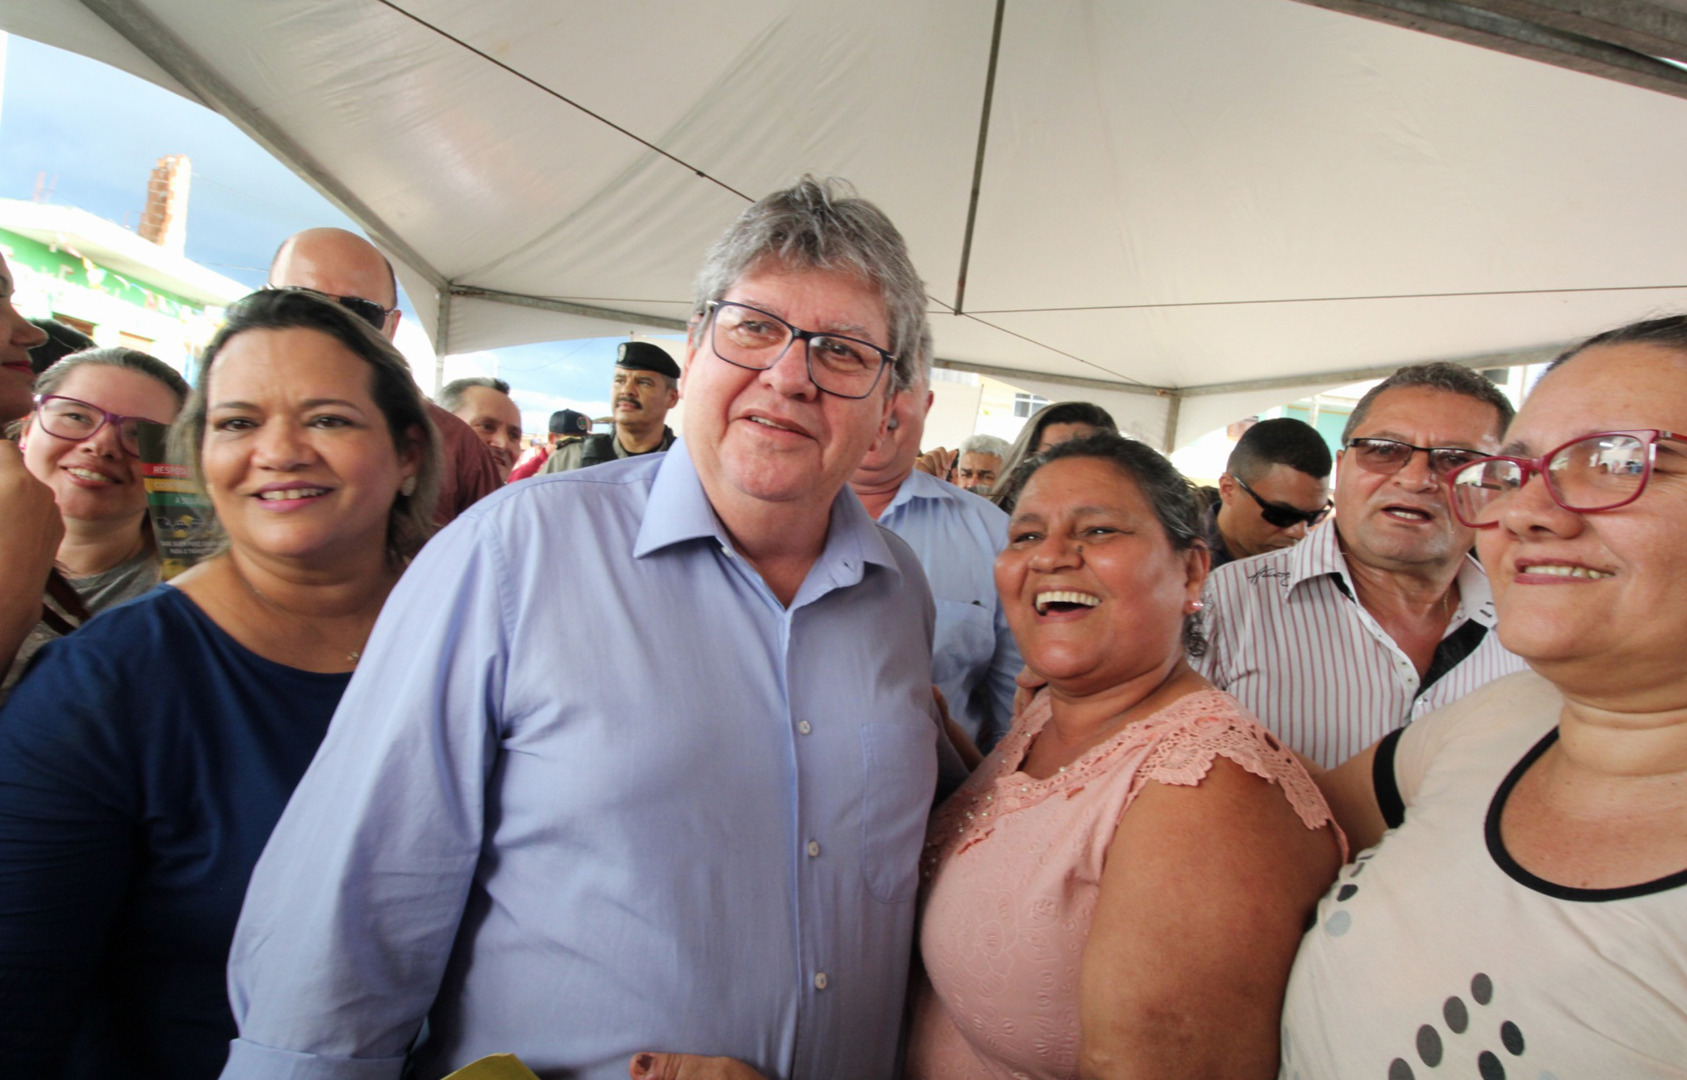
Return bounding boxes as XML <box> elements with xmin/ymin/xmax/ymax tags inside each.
<box><xmin>1205</xmin><ymin>417</ymin><xmax>1329</xmax><ymax>570</ymax></box>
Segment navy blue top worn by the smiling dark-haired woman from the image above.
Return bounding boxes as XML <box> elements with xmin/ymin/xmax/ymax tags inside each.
<box><xmin>0</xmin><ymin>586</ymin><xmax>351</xmax><ymax>1080</ymax></box>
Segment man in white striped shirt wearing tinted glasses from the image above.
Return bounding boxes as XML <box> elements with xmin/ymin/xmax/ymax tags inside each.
<box><xmin>1198</xmin><ymin>363</ymin><xmax>1523</xmax><ymax>768</ymax></box>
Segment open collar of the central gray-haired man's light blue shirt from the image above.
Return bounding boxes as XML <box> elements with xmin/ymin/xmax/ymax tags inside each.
<box><xmin>633</xmin><ymin>437</ymin><xmax>906</xmax><ymax>584</ymax></box>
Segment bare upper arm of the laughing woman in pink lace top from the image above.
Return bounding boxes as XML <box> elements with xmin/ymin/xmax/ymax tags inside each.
<box><xmin>1080</xmin><ymin>756</ymin><xmax>1339</xmax><ymax>1080</ymax></box>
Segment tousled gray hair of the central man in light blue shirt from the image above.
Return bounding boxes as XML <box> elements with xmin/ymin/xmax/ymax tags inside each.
<box><xmin>692</xmin><ymin>176</ymin><xmax>931</xmax><ymax>390</ymax></box>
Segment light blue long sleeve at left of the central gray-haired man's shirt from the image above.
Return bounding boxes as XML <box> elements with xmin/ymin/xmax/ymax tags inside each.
<box><xmin>223</xmin><ymin>518</ymin><xmax>508</xmax><ymax>1080</ymax></box>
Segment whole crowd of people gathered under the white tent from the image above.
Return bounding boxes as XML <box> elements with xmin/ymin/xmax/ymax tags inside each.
<box><xmin>0</xmin><ymin>179</ymin><xmax>1687</xmax><ymax>1080</ymax></box>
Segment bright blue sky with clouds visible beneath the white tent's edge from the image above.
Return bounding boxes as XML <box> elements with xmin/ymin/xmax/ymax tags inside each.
<box><xmin>0</xmin><ymin>35</ymin><xmax>641</xmax><ymax>434</ymax></box>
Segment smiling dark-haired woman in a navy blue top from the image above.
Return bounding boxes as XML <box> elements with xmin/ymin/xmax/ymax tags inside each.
<box><xmin>0</xmin><ymin>290</ymin><xmax>439</xmax><ymax>1078</ymax></box>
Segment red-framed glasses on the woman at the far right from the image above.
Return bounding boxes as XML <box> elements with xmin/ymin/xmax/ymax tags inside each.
<box><xmin>1447</xmin><ymin>427</ymin><xmax>1684</xmax><ymax>528</ymax></box>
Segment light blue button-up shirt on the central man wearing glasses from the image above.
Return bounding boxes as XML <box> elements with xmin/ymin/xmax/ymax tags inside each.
<box><xmin>224</xmin><ymin>442</ymin><xmax>936</xmax><ymax>1080</ymax></box>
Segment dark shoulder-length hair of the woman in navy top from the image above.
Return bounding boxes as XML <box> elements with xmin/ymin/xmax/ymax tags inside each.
<box><xmin>170</xmin><ymin>289</ymin><xmax>442</xmax><ymax>567</ymax></box>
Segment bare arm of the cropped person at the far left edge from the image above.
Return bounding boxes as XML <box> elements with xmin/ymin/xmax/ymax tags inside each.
<box><xmin>0</xmin><ymin>439</ymin><xmax>64</xmax><ymax>672</ymax></box>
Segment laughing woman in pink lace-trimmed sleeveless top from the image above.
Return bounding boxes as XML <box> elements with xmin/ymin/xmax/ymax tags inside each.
<box><xmin>908</xmin><ymin>435</ymin><xmax>1345</xmax><ymax>1080</ymax></box>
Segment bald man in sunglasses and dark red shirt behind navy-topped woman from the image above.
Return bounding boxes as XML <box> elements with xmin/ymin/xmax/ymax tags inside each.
<box><xmin>270</xmin><ymin>228</ymin><xmax>504</xmax><ymax>528</ymax></box>
